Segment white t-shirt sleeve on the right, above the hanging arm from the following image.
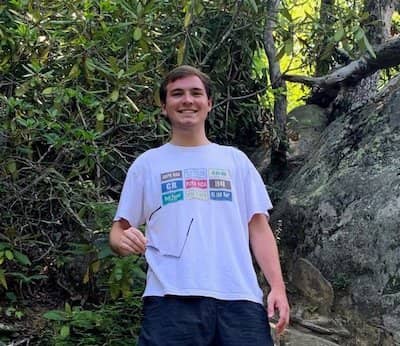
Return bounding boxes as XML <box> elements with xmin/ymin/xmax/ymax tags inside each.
<box><xmin>245</xmin><ymin>158</ymin><xmax>272</xmax><ymax>222</ymax></box>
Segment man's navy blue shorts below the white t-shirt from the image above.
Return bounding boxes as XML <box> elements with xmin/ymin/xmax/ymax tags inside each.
<box><xmin>138</xmin><ymin>296</ymin><xmax>274</xmax><ymax>346</ymax></box>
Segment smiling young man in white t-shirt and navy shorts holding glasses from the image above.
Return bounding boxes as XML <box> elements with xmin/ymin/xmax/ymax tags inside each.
<box><xmin>110</xmin><ymin>66</ymin><xmax>289</xmax><ymax>346</ymax></box>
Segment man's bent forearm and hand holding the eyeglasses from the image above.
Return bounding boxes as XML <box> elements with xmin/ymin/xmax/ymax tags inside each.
<box><xmin>109</xmin><ymin>219</ymin><xmax>147</xmax><ymax>256</ymax></box>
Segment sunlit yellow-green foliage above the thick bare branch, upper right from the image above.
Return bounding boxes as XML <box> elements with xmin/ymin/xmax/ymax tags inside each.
<box><xmin>276</xmin><ymin>0</ymin><xmax>375</xmax><ymax>74</ymax></box>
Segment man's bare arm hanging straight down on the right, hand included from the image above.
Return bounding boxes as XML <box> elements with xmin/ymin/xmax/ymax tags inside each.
<box><xmin>249</xmin><ymin>214</ymin><xmax>290</xmax><ymax>335</ymax></box>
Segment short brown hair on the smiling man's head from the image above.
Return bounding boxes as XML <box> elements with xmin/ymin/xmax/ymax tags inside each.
<box><xmin>160</xmin><ymin>65</ymin><xmax>212</xmax><ymax>104</ymax></box>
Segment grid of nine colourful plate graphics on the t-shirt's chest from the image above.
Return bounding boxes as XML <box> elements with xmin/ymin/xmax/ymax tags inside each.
<box><xmin>161</xmin><ymin>168</ymin><xmax>232</xmax><ymax>205</ymax></box>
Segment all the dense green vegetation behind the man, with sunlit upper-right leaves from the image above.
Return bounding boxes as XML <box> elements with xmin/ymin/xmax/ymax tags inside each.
<box><xmin>0</xmin><ymin>0</ymin><xmax>400</xmax><ymax>345</ymax></box>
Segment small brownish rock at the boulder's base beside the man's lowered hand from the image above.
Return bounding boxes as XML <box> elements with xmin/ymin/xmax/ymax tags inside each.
<box><xmin>291</xmin><ymin>258</ymin><xmax>334</xmax><ymax>315</ymax></box>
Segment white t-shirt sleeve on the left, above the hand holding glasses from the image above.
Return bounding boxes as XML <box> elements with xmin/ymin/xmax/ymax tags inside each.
<box><xmin>114</xmin><ymin>160</ymin><xmax>145</xmax><ymax>227</ymax></box>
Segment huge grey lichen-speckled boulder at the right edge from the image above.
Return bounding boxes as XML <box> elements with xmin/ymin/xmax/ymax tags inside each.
<box><xmin>272</xmin><ymin>76</ymin><xmax>400</xmax><ymax>344</ymax></box>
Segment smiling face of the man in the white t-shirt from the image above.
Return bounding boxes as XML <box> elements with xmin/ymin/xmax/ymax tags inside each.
<box><xmin>162</xmin><ymin>75</ymin><xmax>212</xmax><ymax>130</ymax></box>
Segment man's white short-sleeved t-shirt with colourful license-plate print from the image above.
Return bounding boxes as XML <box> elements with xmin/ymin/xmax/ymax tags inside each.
<box><xmin>114</xmin><ymin>143</ymin><xmax>272</xmax><ymax>303</ymax></box>
